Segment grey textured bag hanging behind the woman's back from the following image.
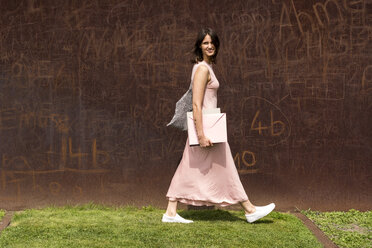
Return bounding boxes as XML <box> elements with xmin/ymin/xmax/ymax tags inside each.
<box><xmin>167</xmin><ymin>83</ymin><xmax>192</xmax><ymax>131</ymax></box>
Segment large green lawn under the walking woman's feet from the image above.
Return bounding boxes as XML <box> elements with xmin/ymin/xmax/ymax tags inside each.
<box><xmin>0</xmin><ymin>204</ymin><xmax>322</xmax><ymax>248</ymax></box>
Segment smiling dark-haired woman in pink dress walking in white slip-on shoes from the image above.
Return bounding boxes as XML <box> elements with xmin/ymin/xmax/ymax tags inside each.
<box><xmin>162</xmin><ymin>28</ymin><xmax>275</xmax><ymax>223</ymax></box>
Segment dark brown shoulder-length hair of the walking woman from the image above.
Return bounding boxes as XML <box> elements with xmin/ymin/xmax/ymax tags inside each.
<box><xmin>191</xmin><ymin>28</ymin><xmax>220</xmax><ymax>64</ymax></box>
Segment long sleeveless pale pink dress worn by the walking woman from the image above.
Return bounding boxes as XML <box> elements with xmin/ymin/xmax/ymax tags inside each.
<box><xmin>167</xmin><ymin>61</ymin><xmax>248</xmax><ymax>206</ymax></box>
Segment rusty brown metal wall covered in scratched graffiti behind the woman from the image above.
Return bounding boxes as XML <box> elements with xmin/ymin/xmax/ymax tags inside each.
<box><xmin>0</xmin><ymin>0</ymin><xmax>372</xmax><ymax>210</ymax></box>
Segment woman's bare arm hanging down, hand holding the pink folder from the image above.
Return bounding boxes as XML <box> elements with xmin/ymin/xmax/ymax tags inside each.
<box><xmin>192</xmin><ymin>65</ymin><xmax>213</xmax><ymax>147</ymax></box>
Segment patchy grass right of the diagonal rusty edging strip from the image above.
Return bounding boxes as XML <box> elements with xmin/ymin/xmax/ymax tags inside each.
<box><xmin>302</xmin><ymin>209</ymin><xmax>372</xmax><ymax>248</ymax></box>
